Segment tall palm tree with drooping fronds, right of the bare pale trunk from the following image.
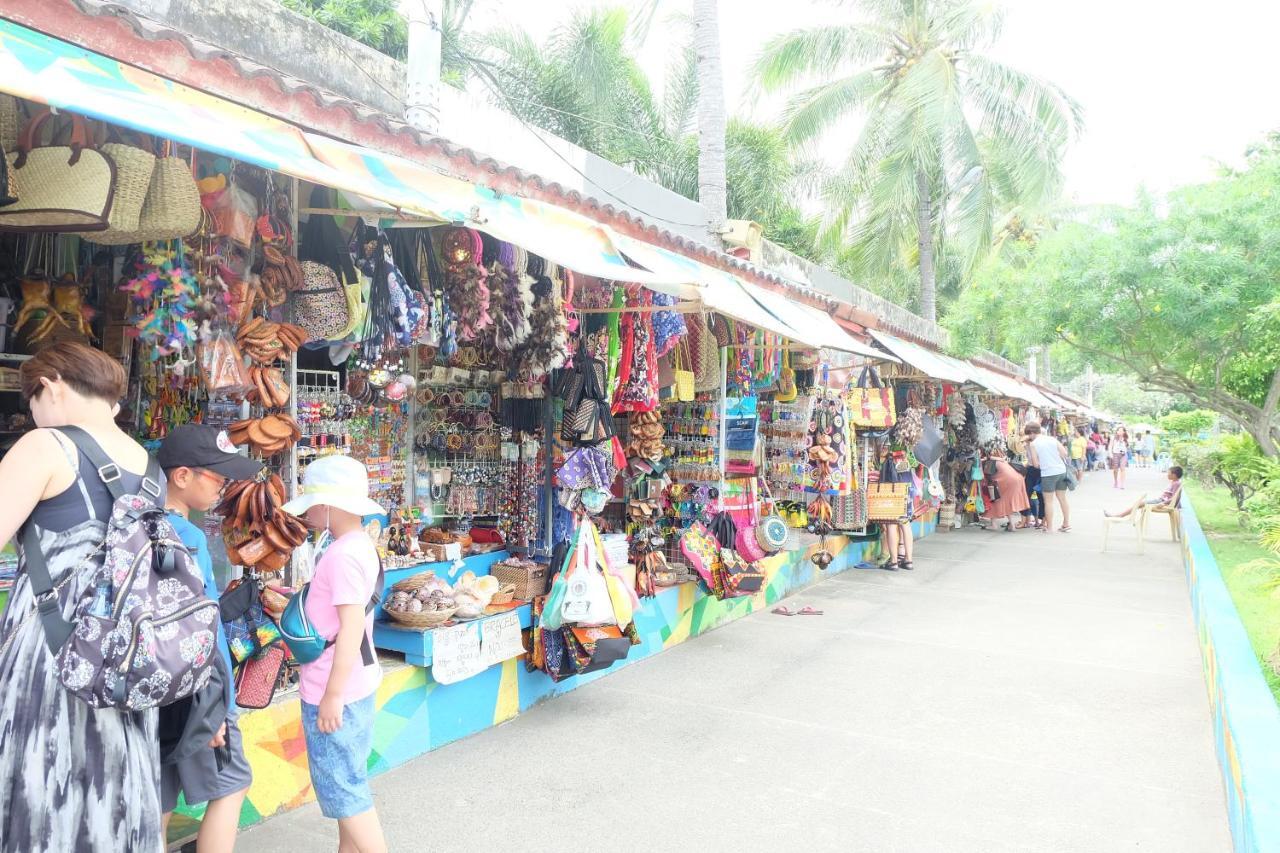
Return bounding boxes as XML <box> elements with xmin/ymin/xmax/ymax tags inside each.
<box><xmin>755</xmin><ymin>0</ymin><xmax>1082</xmax><ymax>320</ymax></box>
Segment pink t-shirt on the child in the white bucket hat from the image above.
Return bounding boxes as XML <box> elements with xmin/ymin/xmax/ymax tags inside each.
<box><xmin>298</xmin><ymin>530</ymin><xmax>383</xmax><ymax>704</ymax></box>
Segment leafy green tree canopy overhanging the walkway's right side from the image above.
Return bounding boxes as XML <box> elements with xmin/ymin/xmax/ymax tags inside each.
<box><xmin>952</xmin><ymin>137</ymin><xmax>1280</xmax><ymax>456</ymax></box>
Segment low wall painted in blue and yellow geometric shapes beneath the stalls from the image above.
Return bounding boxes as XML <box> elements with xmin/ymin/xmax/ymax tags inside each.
<box><xmin>170</xmin><ymin>520</ymin><xmax>933</xmax><ymax>836</ymax></box>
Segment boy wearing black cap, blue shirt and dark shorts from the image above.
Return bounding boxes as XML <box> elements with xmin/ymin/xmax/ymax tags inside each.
<box><xmin>156</xmin><ymin>424</ymin><xmax>262</xmax><ymax>853</ymax></box>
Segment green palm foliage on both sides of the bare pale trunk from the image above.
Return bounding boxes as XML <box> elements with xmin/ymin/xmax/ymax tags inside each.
<box><xmin>472</xmin><ymin>8</ymin><xmax>824</xmax><ymax>260</ymax></box>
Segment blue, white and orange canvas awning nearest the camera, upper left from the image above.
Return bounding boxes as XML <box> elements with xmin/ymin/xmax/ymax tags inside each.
<box><xmin>0</xmin><ymin>20</ymin><xmax>696</xmax><ymax>295</ymax></box>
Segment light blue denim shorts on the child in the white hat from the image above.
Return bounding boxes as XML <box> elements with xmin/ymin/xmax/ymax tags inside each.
<box><xmin>302</xmin><ymin>694</ymin><xmax>376</xmax><ymax>820</ymax></box>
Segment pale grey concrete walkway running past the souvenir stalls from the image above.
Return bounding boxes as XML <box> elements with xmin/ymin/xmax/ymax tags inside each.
<box><xmin>241</xmin><ymin>471</ymin><xmax>1230</xmax><ymax>853</ymax></box>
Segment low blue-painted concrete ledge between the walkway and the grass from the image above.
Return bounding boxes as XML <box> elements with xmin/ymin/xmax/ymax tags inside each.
<box><xmin>1181</xmin><ymin>492</ymin><xmax>1280</xmax><ymax>853</ymax></box>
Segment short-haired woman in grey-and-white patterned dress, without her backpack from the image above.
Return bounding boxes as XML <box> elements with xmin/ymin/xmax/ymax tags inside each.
<box><xmin>0</xmin><ymin>342</ymin><xmax>164</xmax><ymax>853</ymax></box>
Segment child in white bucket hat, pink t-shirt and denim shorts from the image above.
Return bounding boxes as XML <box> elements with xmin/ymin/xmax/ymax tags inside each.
<box><xmin>284</xmin><ymin>456</ymin><xmax>387</xmax><ymax>853</ymax></box>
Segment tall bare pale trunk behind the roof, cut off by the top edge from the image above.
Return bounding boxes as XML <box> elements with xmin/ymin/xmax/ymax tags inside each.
<box><xmin>694</xmin><ymin>0</ymin><xmax>728</xmax><ymax>246</ymax></box>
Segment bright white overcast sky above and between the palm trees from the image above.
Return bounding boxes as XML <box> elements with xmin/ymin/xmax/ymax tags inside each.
<box><xmin>472</xmin><ymin>0</ymin><xmax>1280</xmax><ymax>204</ymax></box>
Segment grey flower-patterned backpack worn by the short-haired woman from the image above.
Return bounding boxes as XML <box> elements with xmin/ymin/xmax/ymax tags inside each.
<box><xmin>22</xmin><ymin>427</ymin><xmax>218</xmax><ymax>711</ymax></box>
